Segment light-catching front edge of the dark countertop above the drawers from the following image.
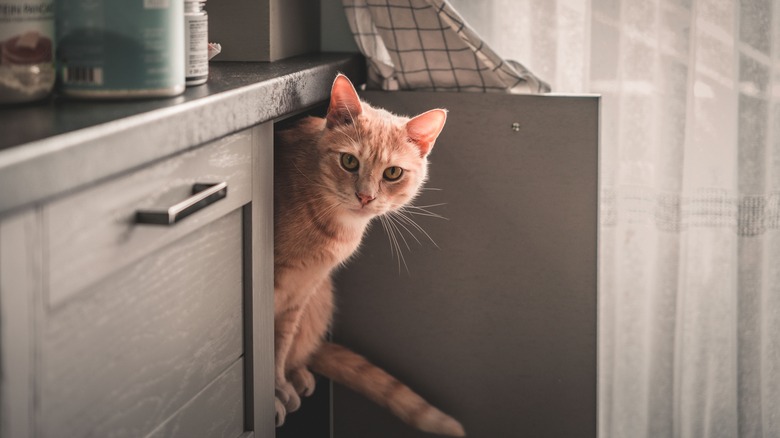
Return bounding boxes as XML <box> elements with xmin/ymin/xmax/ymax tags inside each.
<box><xmin>0</xmin><ymin>54</ymin><xmax>364</xmax><ymax>215</ymax></box>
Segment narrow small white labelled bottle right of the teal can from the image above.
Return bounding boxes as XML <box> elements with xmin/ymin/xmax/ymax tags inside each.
<box><xmin>184</xmin><ymin>0</ymin><xmax>209</xmax><ymax>85</ymax></box>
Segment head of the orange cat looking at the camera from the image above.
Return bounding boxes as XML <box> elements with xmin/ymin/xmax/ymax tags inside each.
<box><xmin>319</xmin><ymin>74</ymin><xmax>447</xmax><ymax>218</ymax></box>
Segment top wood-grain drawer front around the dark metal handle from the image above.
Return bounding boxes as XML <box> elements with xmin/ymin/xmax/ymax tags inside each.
<box><xmin>43</xmin><ymin>130</ymin><xmax>252</xmax><ymax>308</ymax></box>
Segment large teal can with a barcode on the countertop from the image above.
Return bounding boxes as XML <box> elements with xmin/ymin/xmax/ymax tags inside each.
<box><xmin>56</xmin><ymin>0</ymin><xmax>184</xmax><ymax>99</ymax></box>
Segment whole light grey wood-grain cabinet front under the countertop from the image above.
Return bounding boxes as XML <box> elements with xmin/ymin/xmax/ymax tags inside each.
<box><xmin>0</xmin><ymin>123</ymin><xmax>274</xmax><ymax>438</ymax></box>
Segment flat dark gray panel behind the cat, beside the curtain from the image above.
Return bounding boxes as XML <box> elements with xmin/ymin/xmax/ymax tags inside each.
<box><xmin>333</xmin><ymin>92</ymin><xmax>598</xmax><ymax>438</ymax></box>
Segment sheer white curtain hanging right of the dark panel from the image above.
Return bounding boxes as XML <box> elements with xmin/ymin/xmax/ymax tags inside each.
<box><xmin>452</xmin><ymin>0</ymin><xmax>780</xmax><ymax>438</ymax></box>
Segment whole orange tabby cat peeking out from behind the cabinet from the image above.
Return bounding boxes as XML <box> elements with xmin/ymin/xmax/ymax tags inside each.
<box><xmin>274</xmin><ymin>75</ymin><xmax>465</xmax><ymax>436</ymax></box>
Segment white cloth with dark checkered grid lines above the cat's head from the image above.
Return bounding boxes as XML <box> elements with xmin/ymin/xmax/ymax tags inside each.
<box><xmin>342</xmin><ymin>0</ymin><xmax>550</xmax><ymax>93</ymax></box>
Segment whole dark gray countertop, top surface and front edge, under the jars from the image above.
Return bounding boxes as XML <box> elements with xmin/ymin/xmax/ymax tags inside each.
<box><xmin>0</xmin><ymin>53</ymin><xmax>365</xmax><ymax>214</ymax></box>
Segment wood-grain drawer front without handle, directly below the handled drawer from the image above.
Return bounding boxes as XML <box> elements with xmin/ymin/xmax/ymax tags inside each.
<box><xmin>36</xmin><ymin>209</ymin><xmax>243</xmax><ymax>438</ymax></box>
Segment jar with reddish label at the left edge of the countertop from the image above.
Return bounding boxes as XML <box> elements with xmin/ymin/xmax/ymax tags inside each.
<box><xmin>0</xmin><ymin>0</ymin><xmax>55</xmax><ymax>104</ymax></box>
